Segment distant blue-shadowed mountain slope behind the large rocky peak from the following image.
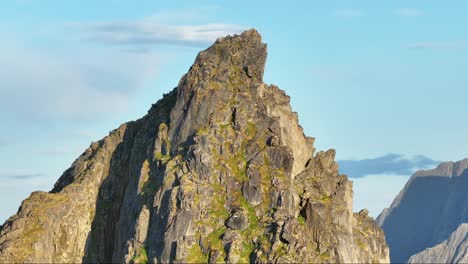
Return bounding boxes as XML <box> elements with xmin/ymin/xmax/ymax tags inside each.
<box><xmin>377</xmin><ymin>159</ymin><xmax>468</xmax><ymax>263</ymax></box>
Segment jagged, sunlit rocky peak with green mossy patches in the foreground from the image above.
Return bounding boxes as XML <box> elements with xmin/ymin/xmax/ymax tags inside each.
<box><xmin>0</xmin><ymin>30</ymin><xmax>389</xmax><ymax>263</ymax></box>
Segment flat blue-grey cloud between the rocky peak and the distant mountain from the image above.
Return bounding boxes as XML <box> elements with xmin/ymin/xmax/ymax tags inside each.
<box><xmin>338</xmin><ymin>154</ymin><xmax>439</xmax><ymax>178</ymax></box>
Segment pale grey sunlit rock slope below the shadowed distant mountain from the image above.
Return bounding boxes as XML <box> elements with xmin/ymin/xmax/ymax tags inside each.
<box><xmin>409</xmin><ymin>223</ymin><xmax>468</xmax><ymax>263</ymax></box>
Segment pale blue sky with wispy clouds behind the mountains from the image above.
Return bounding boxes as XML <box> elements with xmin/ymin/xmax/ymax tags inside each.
<box><xmin>0</xmin><ymin>0</ymin><xmax>468</xmax><ymax>221</ymax></box>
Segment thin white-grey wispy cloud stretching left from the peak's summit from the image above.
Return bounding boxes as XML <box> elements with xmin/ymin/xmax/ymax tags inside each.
<box><xmin>68</xmin><ymin>6</ymin><xmax>248</xmax><ymax>53</ymax></box>
